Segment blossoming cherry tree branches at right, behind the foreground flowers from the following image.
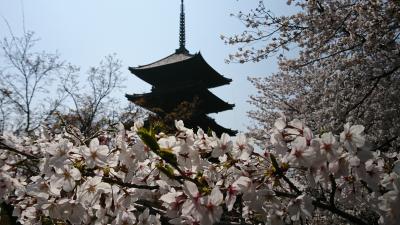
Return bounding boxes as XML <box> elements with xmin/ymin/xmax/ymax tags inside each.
<box><xmin>223</xmin><ymin>0</ymin><xmax>400</xmax><ymax>153</ymax></box>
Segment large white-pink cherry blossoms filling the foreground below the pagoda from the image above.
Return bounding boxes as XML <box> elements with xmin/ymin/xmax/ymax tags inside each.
<box><xmin>0</xmin><ymin>117</ymin><xmax>400</xmax><ymax>225</ymax></box>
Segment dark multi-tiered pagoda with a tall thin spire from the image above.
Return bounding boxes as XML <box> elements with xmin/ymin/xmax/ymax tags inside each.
<box><xmin>126</xmin><ymin>0</ymin><xmax>237</xmax><ymax>135</ymax></box>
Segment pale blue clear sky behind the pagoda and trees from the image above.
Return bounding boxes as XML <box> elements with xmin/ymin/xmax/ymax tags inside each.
<box><xmin>0</xmin><ymin>0</ymin><xmax>291</xmax><ymax>132</ymax></box>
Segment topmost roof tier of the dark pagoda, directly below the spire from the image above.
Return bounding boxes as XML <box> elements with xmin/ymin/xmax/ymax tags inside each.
<box><xmin>129</xmin><ymin>51</ymin><xmax>232</xmax><ymax>88</ymax></box>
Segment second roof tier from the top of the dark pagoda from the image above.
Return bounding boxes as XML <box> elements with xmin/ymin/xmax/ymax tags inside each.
<box><xmin>126</xmin><ymin>86</ymin><xmax>235</xmax><ymax>114</ymax></box>
